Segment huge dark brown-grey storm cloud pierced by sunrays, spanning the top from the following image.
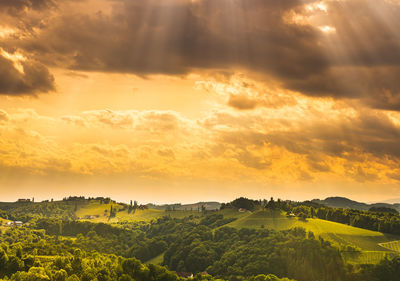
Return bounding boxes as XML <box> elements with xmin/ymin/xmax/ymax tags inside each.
<box><xmin>0</xmin><ymin>0</ymin><xmax>400</xmax><ymax>110</ymax></box>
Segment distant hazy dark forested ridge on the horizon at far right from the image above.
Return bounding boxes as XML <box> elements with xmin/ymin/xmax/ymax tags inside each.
<box><xmin>311</xmin><ymin>197</ymin><xmax>400</xmax><ymax>211</ymax></box>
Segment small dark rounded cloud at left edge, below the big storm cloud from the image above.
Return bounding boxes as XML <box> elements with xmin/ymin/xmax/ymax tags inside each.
<box><xmin>0</xmin><ymin>54</ymin><xmax>54</xmax><ymax>95</ymax></box>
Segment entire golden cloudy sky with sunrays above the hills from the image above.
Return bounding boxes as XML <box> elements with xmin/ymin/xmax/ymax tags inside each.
<box><xmin>0</xmin><ymin>0</ymin><xmax>400</xmax><ymax>203</ymax></box>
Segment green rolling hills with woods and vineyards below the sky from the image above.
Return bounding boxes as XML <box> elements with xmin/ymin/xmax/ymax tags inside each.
<box><xmin>0</xmin><ymin>197</ymin><xmax>400</xmax><ymax>281</ymax></box>
